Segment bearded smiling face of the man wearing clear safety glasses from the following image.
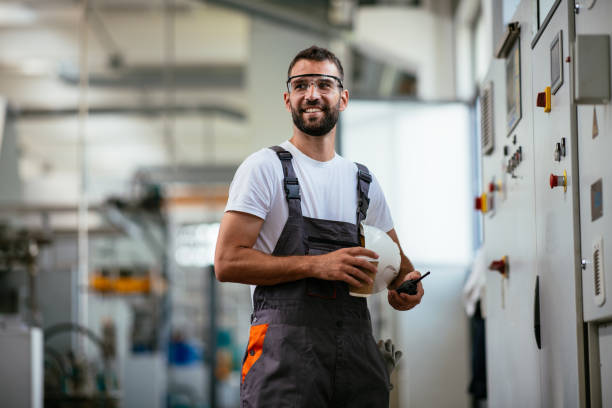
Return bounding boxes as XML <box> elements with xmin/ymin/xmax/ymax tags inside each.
<box><xmin>283</xmin><ymin>59</ymin><xmax>348</xmax><ymax>136</ymax></box>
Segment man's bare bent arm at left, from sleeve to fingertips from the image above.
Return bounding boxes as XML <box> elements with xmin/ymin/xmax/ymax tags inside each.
<box><xmin>215</xmin><ymin>211</ymin><xmax>378</xmax><ymax>286</ymax></box>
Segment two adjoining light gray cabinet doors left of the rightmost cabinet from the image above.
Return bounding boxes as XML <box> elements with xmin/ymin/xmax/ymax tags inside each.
<box><xmin>482</xmin><ymin>0</ymin><xmax>588</xmax><ymax>407</ymax></box>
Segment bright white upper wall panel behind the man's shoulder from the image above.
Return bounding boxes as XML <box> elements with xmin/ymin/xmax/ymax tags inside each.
<box><xmin>342</xmin><ymin>101</ymin><xmax>473</xmax><ymax>266</ymax></box>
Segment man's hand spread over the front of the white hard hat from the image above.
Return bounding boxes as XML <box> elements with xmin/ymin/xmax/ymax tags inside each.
<box><xmin>309</xmin><ymin>247</ymin><xmax>378</xmax><ymax>287</ymax></box>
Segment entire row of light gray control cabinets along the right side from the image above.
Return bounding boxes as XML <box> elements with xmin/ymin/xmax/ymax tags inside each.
<box><xmin>476</xmin><ymin>0</ymin><xmax>612</xmax><ymax>407</ymax></box>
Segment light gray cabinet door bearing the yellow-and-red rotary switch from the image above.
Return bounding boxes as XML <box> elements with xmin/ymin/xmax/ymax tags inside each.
<box><xmin>531</xmin><ymin>0</ymin><xmax>585</xmax><ymax>407</ymax></box>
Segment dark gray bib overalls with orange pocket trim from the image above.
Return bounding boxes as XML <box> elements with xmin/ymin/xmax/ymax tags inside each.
<box><xmin>240</xmin><ymin>146</ymin><xmax>389</xmax><ymax>408</ymax></box>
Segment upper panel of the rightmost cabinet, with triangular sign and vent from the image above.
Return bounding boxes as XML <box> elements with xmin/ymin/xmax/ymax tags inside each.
<box><xmin>575</xmin><ymin>1</ymin><xmax>612</xmax><ymax>326</ymax></box>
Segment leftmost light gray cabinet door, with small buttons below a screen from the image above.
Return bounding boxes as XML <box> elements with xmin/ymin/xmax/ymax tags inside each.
<box><xmin>482</xmin><ymin>2</ymin><xmax>541</xmax><ymax>408</ymax></box>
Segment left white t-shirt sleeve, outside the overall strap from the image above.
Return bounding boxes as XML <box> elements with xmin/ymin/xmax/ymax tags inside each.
<box><xmin>225</xmin><ymin>151</ymin><xmax>276</xmax><ymax>220</ymax></box>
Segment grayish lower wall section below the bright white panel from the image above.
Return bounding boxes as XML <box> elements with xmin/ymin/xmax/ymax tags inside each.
<box><xmin>396</xmin><ymin>264</ymin><xmax>470</xmax><ymax>408</ymax></box>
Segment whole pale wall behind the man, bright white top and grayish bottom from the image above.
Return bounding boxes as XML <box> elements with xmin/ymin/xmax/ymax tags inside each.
<box><xmin>341</xmin><ymin>101</ymin><xmax>473</xmax><ymax>408</ymax></box>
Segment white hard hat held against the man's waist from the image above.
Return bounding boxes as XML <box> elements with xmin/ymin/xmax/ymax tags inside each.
<box><xmin>351</xmin><ymin>224</ymin><xmax>402</xmax><ymax>297</ymax></box>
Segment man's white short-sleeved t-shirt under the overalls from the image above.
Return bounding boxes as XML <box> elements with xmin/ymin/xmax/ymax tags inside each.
<box><xmin>225</xmin><ymin>141</ymin><xmax>393</xmax><ymax>254</ymax></box>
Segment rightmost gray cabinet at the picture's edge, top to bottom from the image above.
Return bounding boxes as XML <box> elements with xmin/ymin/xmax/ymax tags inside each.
<box><xmin>576</xmin><ymin>0</ymin><xmax>612</xmax><ymax>407</ymax></box>
